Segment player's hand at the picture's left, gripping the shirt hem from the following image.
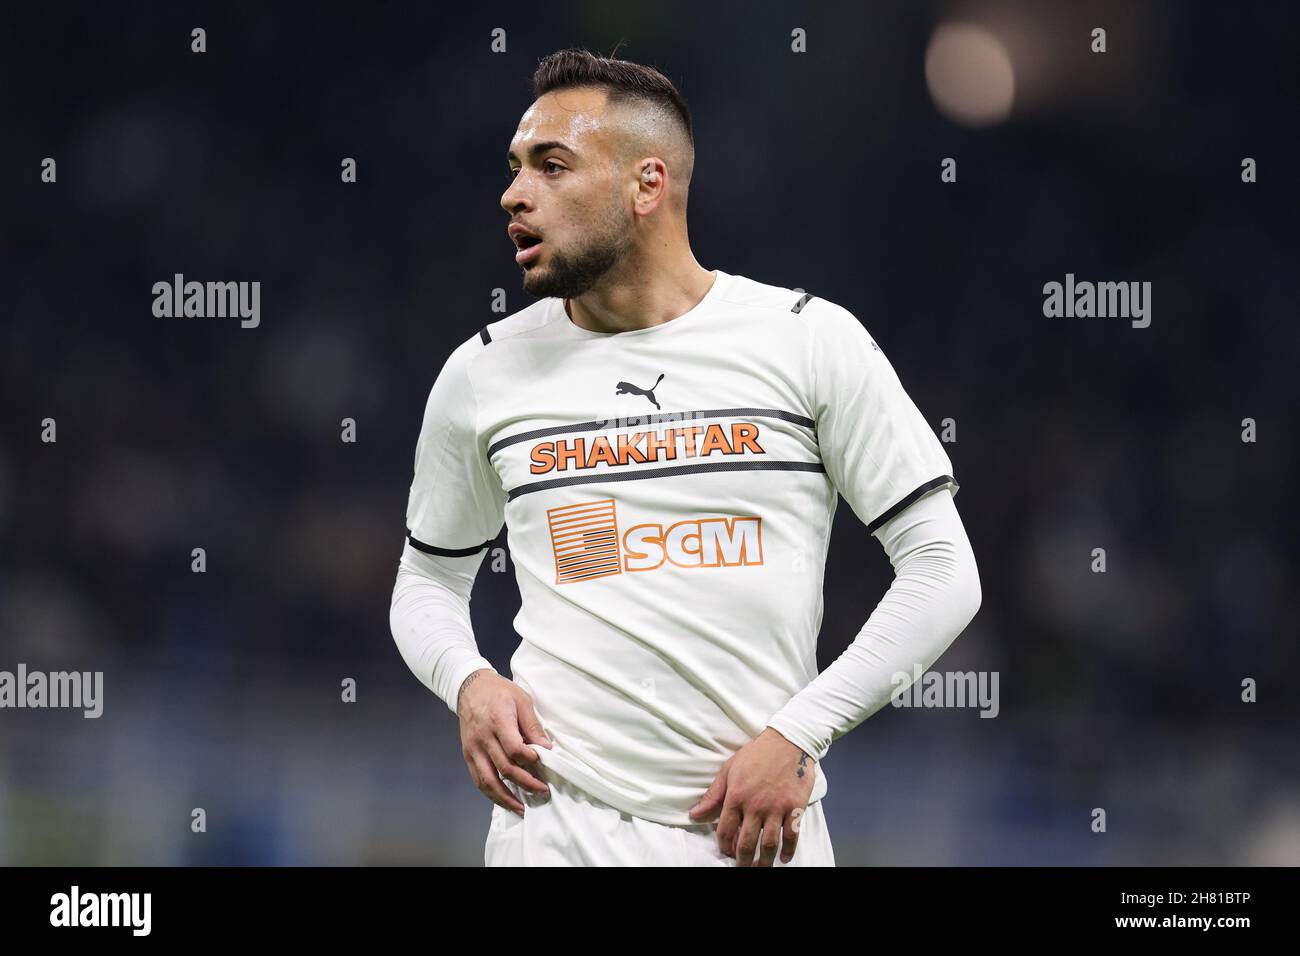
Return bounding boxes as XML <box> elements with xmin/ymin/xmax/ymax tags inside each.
<box><xmin>456</xmin><ymin>669</ymin><xmax>551</xmax><ymax>817</ymax></box>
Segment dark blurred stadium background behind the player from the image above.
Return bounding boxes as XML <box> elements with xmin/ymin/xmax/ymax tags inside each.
<box><xmin>0</xmin><ymin>1</ymin><xmax>1300</xmax><ymax>865</ymax></box>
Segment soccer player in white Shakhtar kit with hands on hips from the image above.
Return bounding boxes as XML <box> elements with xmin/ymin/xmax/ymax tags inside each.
<box><xmin>390</xmin><ymin>49</ymin><xmax>980</xmax><ymax>865</ymax></box>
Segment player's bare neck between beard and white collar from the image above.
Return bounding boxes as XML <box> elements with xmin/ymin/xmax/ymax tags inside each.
<box><xmin>564</xmin><ymin>248</ymin><xmax>715</xmax><ymax>332</ymax></box>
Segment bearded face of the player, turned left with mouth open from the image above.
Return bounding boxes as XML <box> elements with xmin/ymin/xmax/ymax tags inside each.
<box><xmin>501</xmin><ymin>88</ymin><xmax>633</xmax><ymax>298</ymax></box>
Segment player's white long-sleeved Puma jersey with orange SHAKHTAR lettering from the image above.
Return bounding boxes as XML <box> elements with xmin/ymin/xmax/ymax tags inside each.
<box><xmin>393</xmin><ymin>271</ymin><xmax>978</xmax><ymax>825</ymax></box>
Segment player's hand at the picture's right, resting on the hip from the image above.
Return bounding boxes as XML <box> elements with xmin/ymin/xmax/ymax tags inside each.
<box><xmin>690</xmin><ymin>727</ymin><xmax>816</xmax><ymax>866</ymax></box>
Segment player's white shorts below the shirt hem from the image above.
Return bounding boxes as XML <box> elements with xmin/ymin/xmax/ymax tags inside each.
<box><xmin>484</xmin><ymin>774</ymin><xmax>835</xmax><ymax>866</ymax></box>
